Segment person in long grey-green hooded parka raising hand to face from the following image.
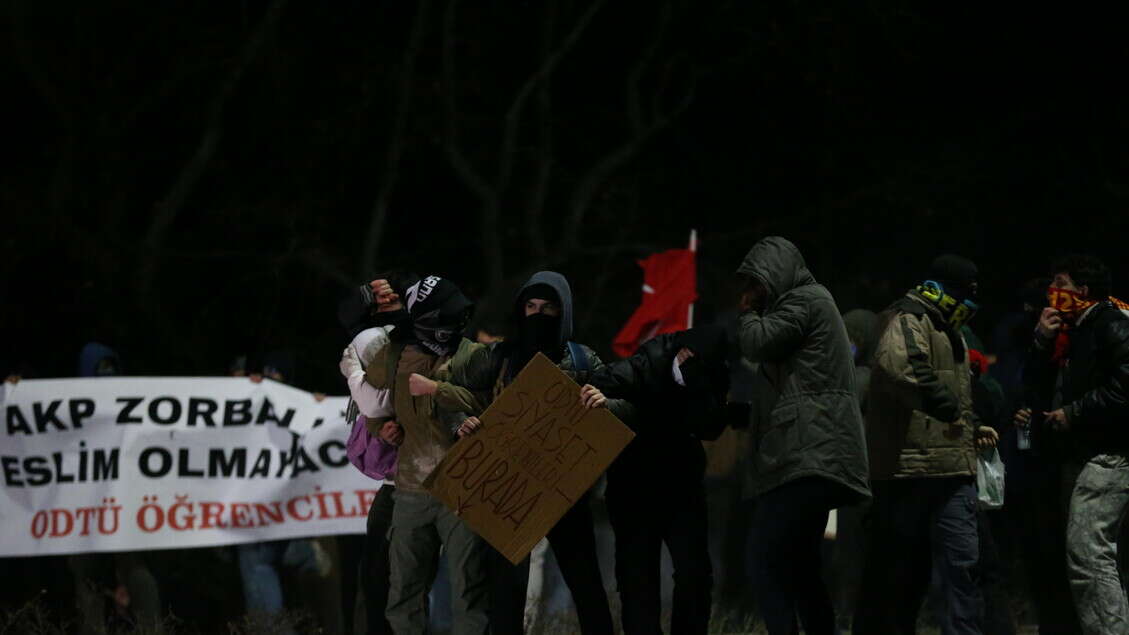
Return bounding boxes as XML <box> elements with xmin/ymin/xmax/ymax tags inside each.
<box><xmin>737</xmin><ymin>236</ymin><xmax>870</xmax><ymax>635</ymax></box>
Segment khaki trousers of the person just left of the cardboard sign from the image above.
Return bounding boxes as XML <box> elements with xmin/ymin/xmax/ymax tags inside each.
<box><xmin>385</xmin><ymin>489</ymin><xmax>490</xmax><ymax>635</ymax></box>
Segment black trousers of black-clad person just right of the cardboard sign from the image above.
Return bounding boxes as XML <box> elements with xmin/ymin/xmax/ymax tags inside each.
<box><xmin>607</xmin><ymin>476</ymin><xmax>714</xmax><ymax>635</ymax></box>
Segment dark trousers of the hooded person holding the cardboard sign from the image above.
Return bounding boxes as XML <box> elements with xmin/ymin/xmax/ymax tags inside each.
<box><xmin>489</xmin><ymin>495</ymin><xmax>613</xmax><ymax>635</ymax></box>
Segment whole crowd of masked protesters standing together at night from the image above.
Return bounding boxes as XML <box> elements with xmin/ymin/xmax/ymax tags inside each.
<box><xmin>2</xmin><ymin>237</ymin><xmax>1129</xmax><ymax>635</ymax></box>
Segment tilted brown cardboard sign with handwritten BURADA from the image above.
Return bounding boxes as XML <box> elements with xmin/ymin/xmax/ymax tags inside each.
<box><xmin>427</xmin><ymin>354</ymin><xmax>634</xmax><ymax>564</ymax></box>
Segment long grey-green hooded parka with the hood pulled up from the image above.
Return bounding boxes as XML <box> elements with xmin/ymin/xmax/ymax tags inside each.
<box><xmin>737</xmin><ymin>236</ymin><xmax>870</xmax><ymax>498</ymax></box>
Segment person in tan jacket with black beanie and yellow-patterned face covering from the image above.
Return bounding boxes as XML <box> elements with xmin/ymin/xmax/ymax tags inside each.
<box><xmin>855</xmin><ymin>254</ymin><xmax>997</xmax><ymax>634</ymax></box>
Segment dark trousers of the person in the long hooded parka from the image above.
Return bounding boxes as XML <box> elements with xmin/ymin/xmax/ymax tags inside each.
<box><xmin>750</xmin><ymin>477</ymin><xmax>846</xmax><ymax>635</ymax></box>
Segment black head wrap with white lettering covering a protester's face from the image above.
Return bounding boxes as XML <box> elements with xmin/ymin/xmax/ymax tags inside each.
<box><xmin>406</xmin><ymin>276</ymin><xmax>474</xmax><ymax>355</ymax></box>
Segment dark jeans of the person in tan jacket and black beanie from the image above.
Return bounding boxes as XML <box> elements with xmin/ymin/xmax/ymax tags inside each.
<box><xmin>854</xmin><ymin>477</ymin><xmax>983</xmax><ymax>635</ymax></box>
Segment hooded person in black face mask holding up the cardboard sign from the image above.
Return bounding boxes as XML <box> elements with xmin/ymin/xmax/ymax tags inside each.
<box><xmin>413</xmin><ymin>271</ymin><xmax>629</xmax><ymax>635</ymax></box>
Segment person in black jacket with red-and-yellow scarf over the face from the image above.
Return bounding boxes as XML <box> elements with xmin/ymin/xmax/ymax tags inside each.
<box><xmin>1024</xmin><ymin>255</ymin><xmax>1129</xmax><ymax>634</ymax></box>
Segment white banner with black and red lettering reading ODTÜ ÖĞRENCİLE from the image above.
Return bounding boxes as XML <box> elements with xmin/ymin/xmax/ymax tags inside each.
<box><xmin>0</xmin><ymin>377</ymin><xmax>380</xmax><ymax>556</ymax></box>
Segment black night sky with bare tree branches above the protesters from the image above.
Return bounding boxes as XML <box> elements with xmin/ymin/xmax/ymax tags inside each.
<box><xmin>0</xmin><ymin>0</ymin><xmax>1129</xmax><ymax>393</ymax></box>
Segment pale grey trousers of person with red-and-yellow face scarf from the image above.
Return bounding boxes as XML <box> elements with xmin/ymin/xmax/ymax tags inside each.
<box><xmin>1066</xmin><ymin>454</ymin><xmax>1129</xmax><ymax>634</ymax></box>
